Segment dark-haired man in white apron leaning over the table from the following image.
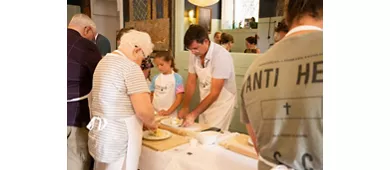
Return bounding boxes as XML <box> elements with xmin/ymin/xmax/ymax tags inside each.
<box><xmin>178</xmin><ymin>25</ymin><xmax>236</xmax><ymax>131</ymax></box>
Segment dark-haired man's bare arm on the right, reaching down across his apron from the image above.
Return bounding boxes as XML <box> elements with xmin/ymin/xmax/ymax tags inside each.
<box><xmin>191</xmin><ymin>78</ymin><xmax>225</xmax><ymax>117</ymax></box>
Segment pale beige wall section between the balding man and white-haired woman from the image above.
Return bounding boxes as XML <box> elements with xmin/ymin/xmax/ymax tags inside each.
<box><xmin>91</xmin><ymin>0</ymin><xmax>120</xmax><ymax>50</ymax></box>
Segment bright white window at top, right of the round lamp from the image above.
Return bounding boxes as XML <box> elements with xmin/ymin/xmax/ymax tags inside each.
<box><xmin>221</xmin><ymin>0</ymin><xmax>260</xmax><ymax>29</ymax></box>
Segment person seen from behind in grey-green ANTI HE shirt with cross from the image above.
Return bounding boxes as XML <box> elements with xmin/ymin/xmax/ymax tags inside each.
<box><xmin>241</xmin><ymin>0</ymin><xmax>323</xmax><ymax>170</ymax></box>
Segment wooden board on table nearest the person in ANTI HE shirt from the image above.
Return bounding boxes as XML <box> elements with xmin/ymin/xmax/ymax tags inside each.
<box><xmin>219</xmin><ymin>134</ymin><xmax>258</xmax><ymax>159</ymax></box>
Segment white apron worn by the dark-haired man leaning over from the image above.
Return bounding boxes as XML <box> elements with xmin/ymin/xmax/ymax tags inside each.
<box><xmin>195</xmin><ymin>59</ymin><xmax>236</xmax><ymax>131</ymax></box>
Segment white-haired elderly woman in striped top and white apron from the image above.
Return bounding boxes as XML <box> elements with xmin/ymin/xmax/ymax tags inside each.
<box><xmin>87</xmin><ymin>30</ymin><xmax>157</xmax><ymax>170</ymax></box>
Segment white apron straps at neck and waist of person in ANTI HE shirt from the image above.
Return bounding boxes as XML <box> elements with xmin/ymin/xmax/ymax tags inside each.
<box><xmin>259</xmin><ymin>25</ymin><xmax>322</xmax><ymax>170</ymax></box>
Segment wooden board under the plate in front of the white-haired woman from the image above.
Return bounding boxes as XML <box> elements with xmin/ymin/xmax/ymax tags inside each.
<box><xmin>142</xmin><ymin>133</ymin><xmax>189</xmax><ymax>151</ymax></box>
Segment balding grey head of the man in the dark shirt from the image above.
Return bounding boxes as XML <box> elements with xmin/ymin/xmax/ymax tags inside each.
<box><xmin>68</xmin><ymin>14</ymin><xmax>97</xmax><ymax>41</ymax></box>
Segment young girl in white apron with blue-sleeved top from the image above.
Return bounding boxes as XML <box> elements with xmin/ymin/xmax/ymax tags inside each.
<box><xmin>150</xmin><ymin>52</ymin><xmax>184</xmax><ymax>117</ymax></box>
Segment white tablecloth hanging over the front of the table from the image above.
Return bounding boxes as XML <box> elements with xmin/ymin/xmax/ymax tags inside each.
<box><xmin>139</xmin><ymin>133</ymin><xmax>257</xmax><ymax>170</ymax></box>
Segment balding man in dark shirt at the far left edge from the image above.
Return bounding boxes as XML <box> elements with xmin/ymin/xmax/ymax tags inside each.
<box><xmin>67</xmin><ymin>14</ymin><xmax>102</xmax><ymax>170</ymax></box>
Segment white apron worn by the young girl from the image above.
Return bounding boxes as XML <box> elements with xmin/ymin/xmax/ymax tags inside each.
<box><xmin>153</xmin><ymin>71</ymin><xmax>177</xmax><ymax>117</ymax></box>
